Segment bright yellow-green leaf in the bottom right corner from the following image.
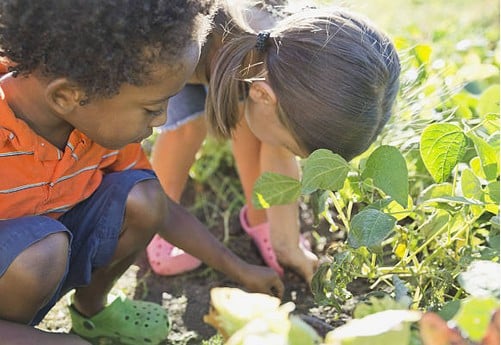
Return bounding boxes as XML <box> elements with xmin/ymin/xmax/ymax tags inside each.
<box><xmin>453</xmin><ymin>297</ymin><xmax>499</xmax><ymax>342</ymax></box>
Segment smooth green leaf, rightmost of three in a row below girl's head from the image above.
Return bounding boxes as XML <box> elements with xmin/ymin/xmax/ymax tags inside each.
<box><xmin>362</xmin><ymin>145</ymin><xmax>409</xmax><ymax>208</ymax></box>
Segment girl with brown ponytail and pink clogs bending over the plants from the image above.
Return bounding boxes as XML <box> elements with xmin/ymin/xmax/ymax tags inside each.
<box><xmin>148</xmin><ymin>1</ymin><xmax>400</xmax><ymax>282</ymax></box>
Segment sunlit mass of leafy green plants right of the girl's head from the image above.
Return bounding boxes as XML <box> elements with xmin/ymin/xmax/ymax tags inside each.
<box><xmin>200</xmin><ymin>3</ymin><xmax>500</xmax><ymax>345</ymax></box>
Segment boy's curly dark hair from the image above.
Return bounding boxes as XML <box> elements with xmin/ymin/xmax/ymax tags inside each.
<box><xmin>0</xmin><ymin>0</ymin><xmax>215</xmax><ymax>97</ymax></box>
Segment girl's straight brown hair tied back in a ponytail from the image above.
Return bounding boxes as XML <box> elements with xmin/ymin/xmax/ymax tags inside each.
<box><xmin>206</xmin><ymin>8</ymin><xmax>400</xmax><ymax>160</ymax></box>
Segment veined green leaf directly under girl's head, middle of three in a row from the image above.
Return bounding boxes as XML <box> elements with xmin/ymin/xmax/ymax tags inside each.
<box><xmin>301</xmin><ymin>149</ymin><xmax>350</xmax><ymax>194</ymax></box>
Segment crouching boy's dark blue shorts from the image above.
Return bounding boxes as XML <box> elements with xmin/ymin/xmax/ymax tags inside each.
<box><xmin>0</xmin><ymin>170</ymin><xmax>156</xmax><ymax>325</ymax></box>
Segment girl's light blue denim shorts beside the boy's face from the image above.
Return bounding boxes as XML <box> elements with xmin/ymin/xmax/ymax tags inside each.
<box><xmin>160</xmin><ymin>84</ymin><xmax>207</xmax><ymax>131</ymax></box>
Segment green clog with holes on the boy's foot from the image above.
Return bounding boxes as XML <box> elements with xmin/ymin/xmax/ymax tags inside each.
<box><xmin>69</xmin><ymin>297</ymin><xmax>171</xmax><ymax>345</ymax></box>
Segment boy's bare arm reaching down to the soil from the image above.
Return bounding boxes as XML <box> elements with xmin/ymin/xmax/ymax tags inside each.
<box><xmin>159</xmin><ymin>192</ymin><xmax>284</xmax><ymax>297</ymax></box>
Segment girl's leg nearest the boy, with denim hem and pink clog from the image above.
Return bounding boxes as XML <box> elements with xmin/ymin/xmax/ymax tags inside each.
<box><xmin>146</xmin><ymin>84</ymin><xmax>207</xmax><ymax>275</ymax></box>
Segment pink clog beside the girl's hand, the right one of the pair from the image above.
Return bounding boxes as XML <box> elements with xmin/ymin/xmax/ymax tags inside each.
<box><xmin>240</xmin><ymin>206</ymin><xmax>284</xmax><ymax>277</ymax></box>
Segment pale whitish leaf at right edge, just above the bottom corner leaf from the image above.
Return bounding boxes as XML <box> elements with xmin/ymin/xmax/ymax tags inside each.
<box><xmin>458</xmin><ymin>260</ymin><xmax>500</xmax><ymax>298</ymax></box>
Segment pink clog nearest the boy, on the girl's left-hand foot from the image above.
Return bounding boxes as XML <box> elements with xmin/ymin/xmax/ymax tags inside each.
<box><xmin>146</xmin><ymin>235</ymin><xmax>202</xmax><ymax>276</ymax></box>
